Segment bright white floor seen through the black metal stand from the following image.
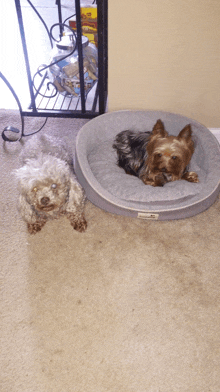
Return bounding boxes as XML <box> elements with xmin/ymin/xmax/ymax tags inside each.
<box><xmin>0</xmin><ymin>0</ymin><xmax>96</xmax><ymax>110</ymax></box>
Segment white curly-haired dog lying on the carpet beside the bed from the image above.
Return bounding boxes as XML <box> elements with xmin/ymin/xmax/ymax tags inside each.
<box><xmin>15</xmin><ymin>134</ymin><xmax>87</xmax><ymax>234</ymax></box>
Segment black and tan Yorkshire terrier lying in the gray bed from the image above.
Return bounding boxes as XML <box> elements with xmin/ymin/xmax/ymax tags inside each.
<box><xmin>113</xmin><ymin>120</ymin><xmax>199</xmax><ymax>186</ymax></box>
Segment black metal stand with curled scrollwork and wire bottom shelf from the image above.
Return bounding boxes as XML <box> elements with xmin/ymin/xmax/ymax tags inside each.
<box><xmin>0</xmin><ymin>0</ymin><xmax>108</xmax><ymax>141</ymax></box>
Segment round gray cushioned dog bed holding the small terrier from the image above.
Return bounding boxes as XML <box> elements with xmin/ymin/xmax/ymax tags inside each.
<box><xmin>75</xmin><ymin>111</ymin><xmax>220</xmax><ymax>220</ymax></box>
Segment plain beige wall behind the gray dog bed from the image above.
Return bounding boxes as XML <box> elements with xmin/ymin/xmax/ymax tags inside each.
<box><xmin>108</xmin><ymin>0</ymin><xmax>220</xmax><ymax>128</ymax></box>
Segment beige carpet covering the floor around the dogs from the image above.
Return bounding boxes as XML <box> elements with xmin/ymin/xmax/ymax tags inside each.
<box><xmin>0</xmin><ymin>111</ymin><xmax>220</xmax><ymax>392</ymax></box>
